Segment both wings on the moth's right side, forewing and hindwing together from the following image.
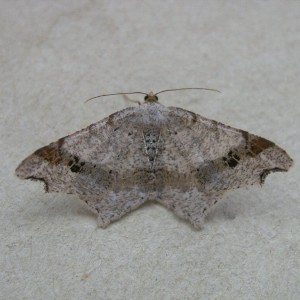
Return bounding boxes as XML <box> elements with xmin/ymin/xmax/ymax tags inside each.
<box><xmin>157</xmin><ymin>107</ymin><xmax>293</xmax><ymax>227</ymax></box>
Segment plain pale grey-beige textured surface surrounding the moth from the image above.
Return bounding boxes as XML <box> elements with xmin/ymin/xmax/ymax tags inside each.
<box><xmin>0</xmin><ymin>0</ymin><xmax>300</xmax><ymax>299</ymax></box>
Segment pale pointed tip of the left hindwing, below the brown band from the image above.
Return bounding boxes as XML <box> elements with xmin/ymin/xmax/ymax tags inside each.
<box><xmin>80</xmin><ymin>193</ymin><xmax>145</xmax><ymax>228</ymax></box>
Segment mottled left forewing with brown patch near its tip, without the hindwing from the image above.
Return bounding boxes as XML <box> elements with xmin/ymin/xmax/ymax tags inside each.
<box><xmin>16</xmin><ymin>108</ymin><xmax>147</xmax><ymax>195</ymax></box>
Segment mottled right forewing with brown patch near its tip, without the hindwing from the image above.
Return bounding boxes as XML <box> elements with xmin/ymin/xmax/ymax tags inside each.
<box><xmin>166</xmin><ymin>108</ymin><xmax>293</xmax><ymax>191</ymax></box>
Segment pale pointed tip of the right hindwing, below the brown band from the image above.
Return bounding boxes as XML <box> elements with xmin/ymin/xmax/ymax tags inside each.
<box><xmin>158</xmin><ymin>192</ymin><xmax>220</xmax><ymax>229</ymax></box>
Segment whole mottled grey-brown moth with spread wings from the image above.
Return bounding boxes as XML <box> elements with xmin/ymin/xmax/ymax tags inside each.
<box><xmin>16</xmin><ymin>90</ymin><xmax>293</xmax><ymax>228</ymax></box>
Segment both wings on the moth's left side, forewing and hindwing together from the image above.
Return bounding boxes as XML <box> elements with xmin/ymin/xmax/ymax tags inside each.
<box><xmin>16</xmin><ymin>108</ymin><xmax>149</xmax><ymax>227</ymax></box>
